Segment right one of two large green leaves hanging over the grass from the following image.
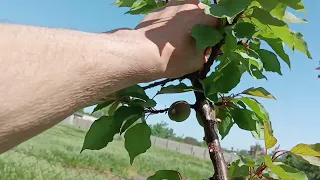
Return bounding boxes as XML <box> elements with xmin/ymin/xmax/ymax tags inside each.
<box><xmin>124</xmin><ymin>123</ymin><xmax>151</xmax><ymax>164</ymax></box>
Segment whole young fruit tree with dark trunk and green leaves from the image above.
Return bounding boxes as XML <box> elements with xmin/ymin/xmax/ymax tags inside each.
<box><xmin>81</xmin><ymin>0</ymin><xmax>320</xmax><ymax>180</ymax></box>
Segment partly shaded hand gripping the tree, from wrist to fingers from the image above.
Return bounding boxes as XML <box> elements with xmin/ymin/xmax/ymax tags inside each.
<box><xmin>136</xmin><ymin>0</ymin><xmax>219</xmax><ymax>78</ymax></box>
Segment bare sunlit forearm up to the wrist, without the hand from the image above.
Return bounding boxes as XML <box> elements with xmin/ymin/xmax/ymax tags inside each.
<box><xmin>0</xmin><ymin>25</ymin><xmax>159</xmax><ymax>153</ymax></box>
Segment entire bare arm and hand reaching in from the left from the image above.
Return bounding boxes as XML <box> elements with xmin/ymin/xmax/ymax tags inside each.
<box><xmin>0</xmin><ymin>0</ymin><xmax>218</xmax><ymax>153</ymax></box>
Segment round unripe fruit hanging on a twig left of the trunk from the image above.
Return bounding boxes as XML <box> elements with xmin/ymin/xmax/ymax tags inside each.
<box><xmin>168</xmin><ymin>101</ymin><xmax>191</xmax><ymax>122</ymax></box>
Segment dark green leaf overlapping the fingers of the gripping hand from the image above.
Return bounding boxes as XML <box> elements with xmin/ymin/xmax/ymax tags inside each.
<box><xmin>191</xmin><ymin>24</ymin><xmax>223</xmax><ymax>51</ymax></box>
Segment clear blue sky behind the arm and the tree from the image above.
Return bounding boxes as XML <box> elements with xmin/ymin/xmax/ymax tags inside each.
<box><xmin>0</xmin><ymin>0</ymin><xmax>320</xmax><ymax>152</ymax></box>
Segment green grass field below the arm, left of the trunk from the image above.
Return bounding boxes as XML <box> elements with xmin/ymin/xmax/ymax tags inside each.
<box><xmin>0</xmin><ymin>125</ymin><xmax>212</xmax><ymax>180</ymax></box>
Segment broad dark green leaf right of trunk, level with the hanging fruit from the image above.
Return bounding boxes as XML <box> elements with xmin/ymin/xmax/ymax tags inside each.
<box><xmin>230</xmin><ymin>108</ymin><xmax>258</xmax><ymax>131</ymax></box>
